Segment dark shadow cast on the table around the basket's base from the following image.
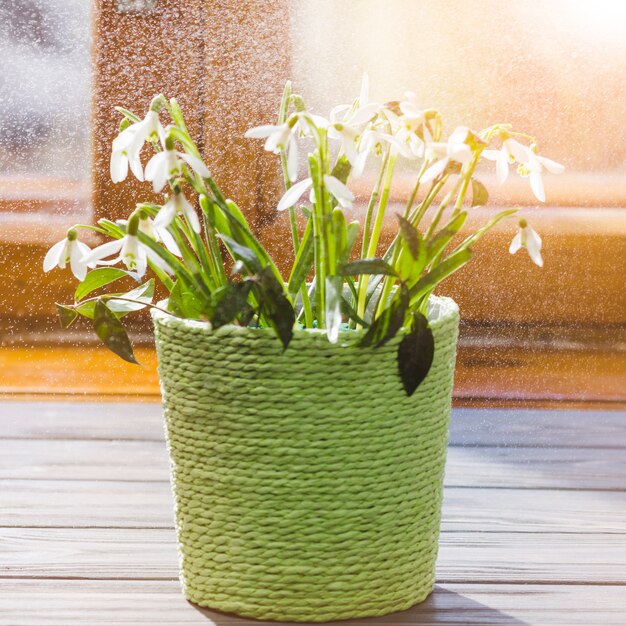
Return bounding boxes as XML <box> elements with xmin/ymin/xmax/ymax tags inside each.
<box><xmin>190</xmin><ymin>586</ymin><xmax>528</xmax><ymax>626</ymax></box>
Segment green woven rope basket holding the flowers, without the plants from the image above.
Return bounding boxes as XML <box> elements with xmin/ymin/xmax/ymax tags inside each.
<box><xmin>153</xmin><ymin>298</ymin><xmax>458</xmax><ymax>622</ymax></box>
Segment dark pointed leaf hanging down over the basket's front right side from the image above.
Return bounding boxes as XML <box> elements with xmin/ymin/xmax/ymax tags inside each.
<box><xmin>398</xmin><ymin>313</ymin><xmax>435</xmax><ymax>396</ymax></box>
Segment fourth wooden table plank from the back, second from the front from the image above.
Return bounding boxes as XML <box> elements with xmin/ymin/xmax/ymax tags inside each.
<box><xmin>0</xmin><ymin>528</ymin><xmax>626</xmax><ymax>585</ymax></box>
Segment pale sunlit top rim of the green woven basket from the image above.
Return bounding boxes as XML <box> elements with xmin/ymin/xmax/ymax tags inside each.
<box><xmin>150</xmin><ymin>296</ymin><xmax>459</xmax><ymax>339</ymax></box>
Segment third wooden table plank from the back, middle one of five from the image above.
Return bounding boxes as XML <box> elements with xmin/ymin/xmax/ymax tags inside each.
<box><xmin>0</xmin><ymin>480</ymin><xmax>626</xmax><ymax>542</ymax></box>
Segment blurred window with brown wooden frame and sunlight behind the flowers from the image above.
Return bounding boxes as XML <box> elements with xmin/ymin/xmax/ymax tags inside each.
<box><xmin>0</xmin><ymin>0</ymin><xmax>626</xmax><ymax>404</ymax></box>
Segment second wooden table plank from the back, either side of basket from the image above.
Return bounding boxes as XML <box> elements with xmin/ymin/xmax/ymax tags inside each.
<box><xmin>0</xmin><ymin>439</ymin><xmax>626</xmax><ymax>491</ymax></box>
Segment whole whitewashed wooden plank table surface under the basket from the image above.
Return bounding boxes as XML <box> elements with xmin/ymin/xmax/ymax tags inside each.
<box><xmin>0</xmin><ymin>401</ymin><xmax>626</xmax><ymax>626</ymax></box>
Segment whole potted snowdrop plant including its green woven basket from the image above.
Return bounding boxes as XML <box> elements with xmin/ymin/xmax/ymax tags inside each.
<box><xmin>44</xmin><ymin>80</ymin><xmax>563</xmax><ymax>621</ymax></box>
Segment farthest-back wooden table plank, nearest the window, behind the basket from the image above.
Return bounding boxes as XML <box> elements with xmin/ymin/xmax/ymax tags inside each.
<box><xmin>0</xmin><ymin>401</ymin><xmax>626</xmax><ymax>448</ymax></box>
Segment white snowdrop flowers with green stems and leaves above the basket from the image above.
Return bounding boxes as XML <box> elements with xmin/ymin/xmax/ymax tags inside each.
<box><xmin>44</xmin><ymin>77</ymin><xmax>563</xmax><ymax>394</ymax></box>
